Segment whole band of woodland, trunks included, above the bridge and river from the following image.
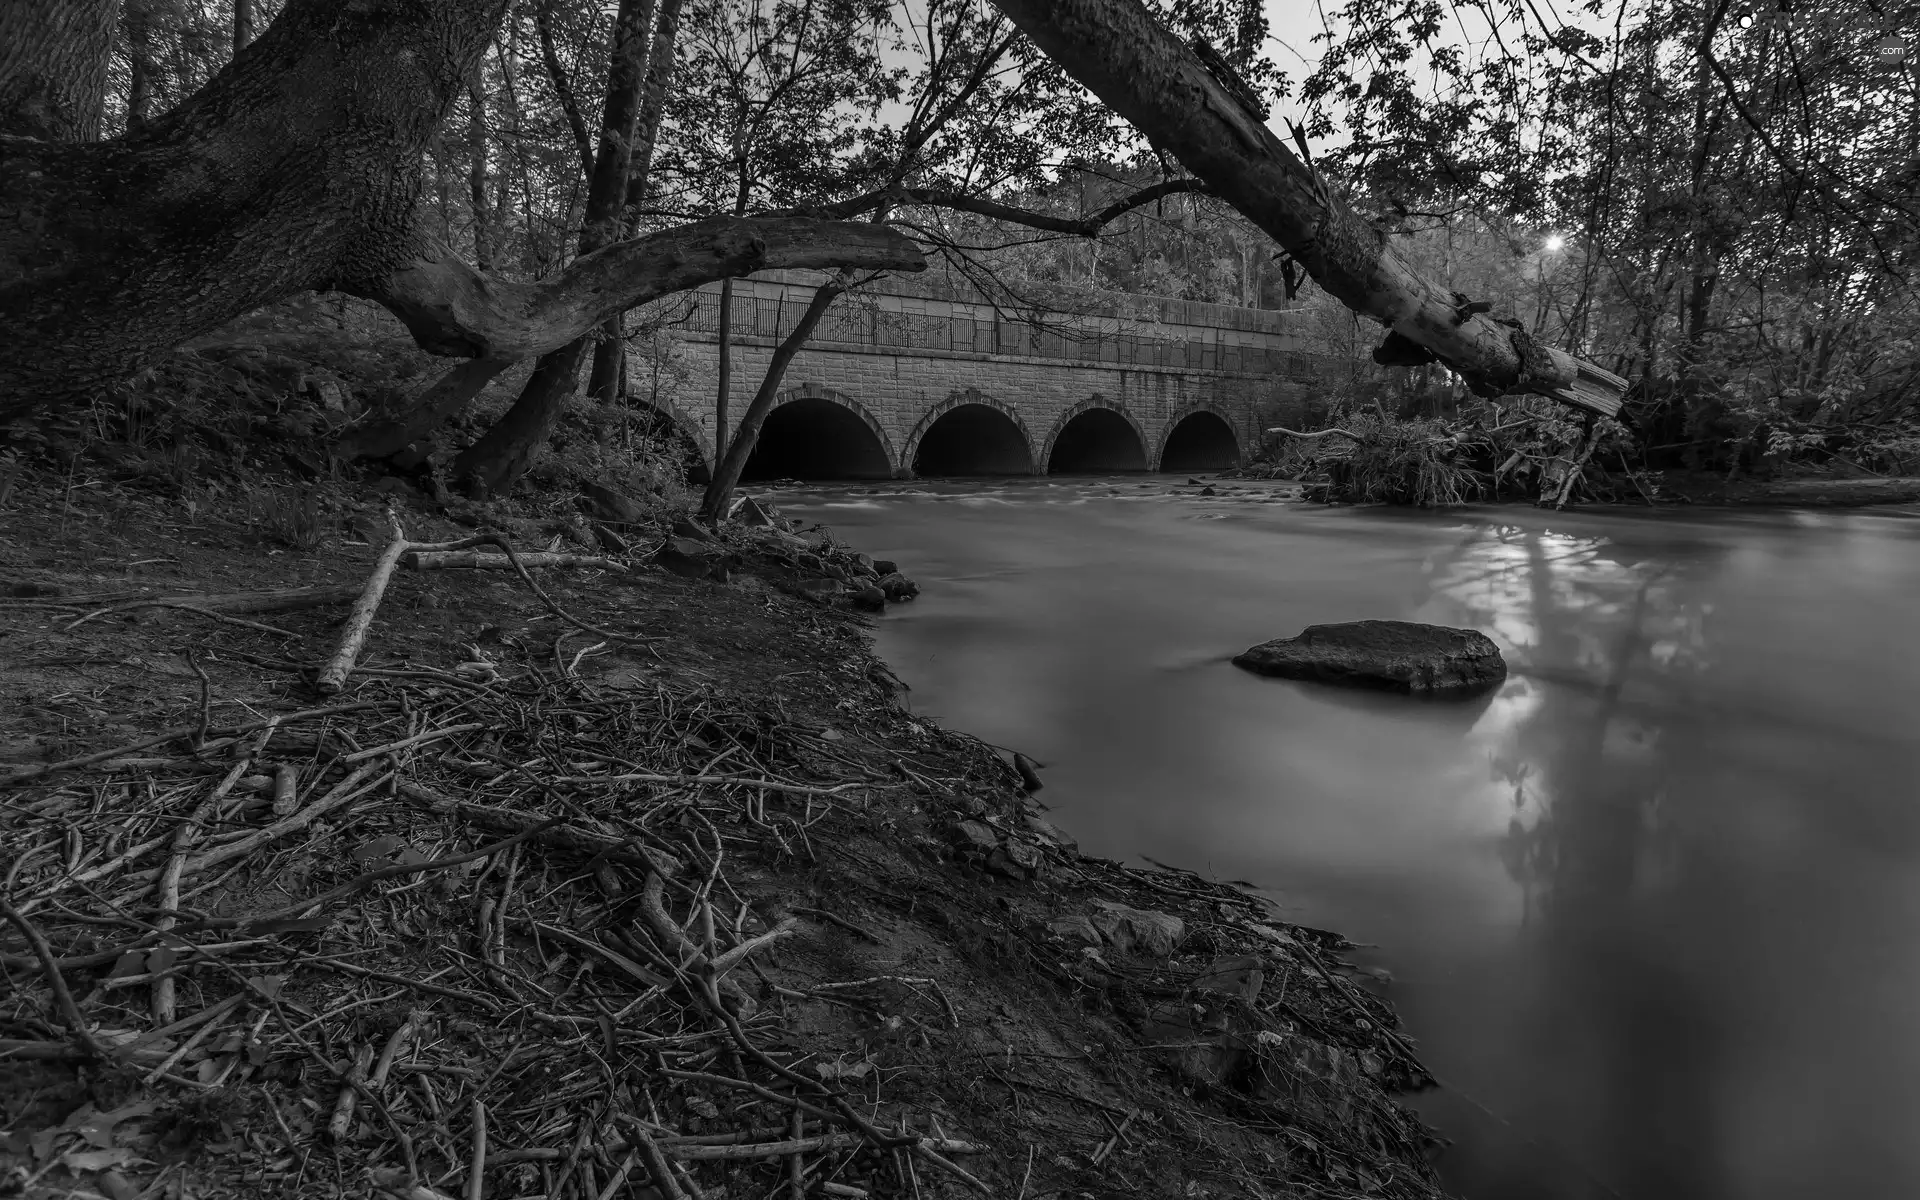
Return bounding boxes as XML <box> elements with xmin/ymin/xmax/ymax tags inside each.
<box><xmin>0</xmin><ymin>0</ymin><xmax>1920</xmax><ymax>488</ymax></box>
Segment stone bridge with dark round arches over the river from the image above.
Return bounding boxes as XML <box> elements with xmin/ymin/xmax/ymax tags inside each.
<box><xmin>630</xmin><ymin>273</ymin><xmax>1327</xmax><ymax>480</ymax></box>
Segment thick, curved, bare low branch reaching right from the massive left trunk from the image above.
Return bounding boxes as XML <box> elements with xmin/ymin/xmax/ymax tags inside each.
<box><xmin>347</xmin><ymin>217</ymin><xmax>927</xmax><ymax>361</ymax></box>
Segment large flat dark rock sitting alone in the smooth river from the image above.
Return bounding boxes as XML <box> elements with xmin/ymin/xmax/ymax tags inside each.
<box><xmin>1233</xmin><ymin>620</ymin><xmax>1507</xmax><ymax>693</ymax></box>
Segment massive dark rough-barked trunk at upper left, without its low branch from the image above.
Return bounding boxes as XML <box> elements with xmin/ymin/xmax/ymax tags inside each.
<box><xmin>0</xmin><ymin>0</ymin><xmax>507</xmax><ymax>415</ymax></box>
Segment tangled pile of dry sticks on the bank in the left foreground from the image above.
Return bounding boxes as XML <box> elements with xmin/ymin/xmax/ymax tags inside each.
<box><xmin>0</xmin><ymin>532</ymin><xmax>987</xmax><ymax>1200</ymax></box>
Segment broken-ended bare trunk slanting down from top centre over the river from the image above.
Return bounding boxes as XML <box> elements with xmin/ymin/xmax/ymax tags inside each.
<box><xmin>995</xmin><ymin>0</ymin><xmax>1626</xmax><ymax>417</ymax></box>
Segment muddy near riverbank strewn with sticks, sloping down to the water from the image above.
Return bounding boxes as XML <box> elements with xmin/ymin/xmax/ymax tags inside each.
<box><xmin>0</xmin><ymin>460</ymin><xmax>1438</xmax><ymax>1200</ymax></box>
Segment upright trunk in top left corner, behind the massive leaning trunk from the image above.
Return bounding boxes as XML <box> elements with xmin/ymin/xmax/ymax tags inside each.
<box><xmin>0</xmin><ymin>0</ymin><xmax>119</xmax><ymax>142</ymax></box>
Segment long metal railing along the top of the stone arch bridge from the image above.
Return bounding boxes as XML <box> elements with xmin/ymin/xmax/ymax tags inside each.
<box><xmin>668</xmin><ymin>290</ymin><xmax>1315</xmax><ymax>378</ymax></box>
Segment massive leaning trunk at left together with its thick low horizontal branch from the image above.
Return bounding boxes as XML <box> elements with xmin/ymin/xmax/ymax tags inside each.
<box><xmin>0</xmin><ymin>0</ymin><xmax>925</xmax><ymax>419</ymax></box>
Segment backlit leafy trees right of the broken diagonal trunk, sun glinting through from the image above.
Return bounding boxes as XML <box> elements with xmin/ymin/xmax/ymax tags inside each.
<box><xmin>1302</xmin><ymin>0</ymin><xmax>1920</xmax><ymax>470</ymax></box>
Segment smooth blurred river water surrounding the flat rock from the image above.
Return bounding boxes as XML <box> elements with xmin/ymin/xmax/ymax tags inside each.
<box><xmin>776</xmin><ymin>476</ymin><xmax>1920</xmax><ymax>1200</ymax></box>
